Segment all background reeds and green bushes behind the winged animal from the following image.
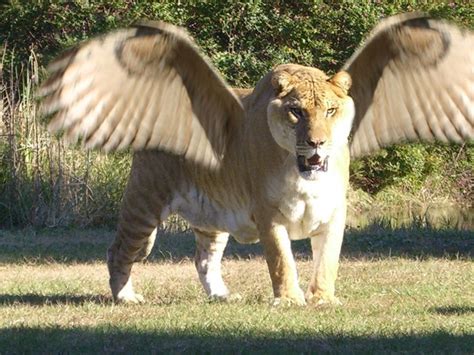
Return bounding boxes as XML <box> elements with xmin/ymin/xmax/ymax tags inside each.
<box><xmin>0</xmin><ymin>0</ymin><xmax>474</xmax><ymax>226</ymax></box>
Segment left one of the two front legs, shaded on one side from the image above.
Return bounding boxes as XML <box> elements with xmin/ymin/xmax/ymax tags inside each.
<box><xmin>260</xmin><ymin>224</ymin><xmax>306</xmax><ymax>305</ymax></box>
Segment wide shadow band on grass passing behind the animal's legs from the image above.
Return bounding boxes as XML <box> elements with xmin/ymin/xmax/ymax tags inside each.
<box><xmin>0</xmin><ymin>224</ymin><xmax>474</xmax><ymax>263</ymax></box>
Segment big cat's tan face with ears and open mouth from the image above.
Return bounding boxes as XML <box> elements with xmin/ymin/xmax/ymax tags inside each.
<box><xmin>267</xmin><ymin>64</ymin><xmax>355</xmax><ymax>180</ymax></box>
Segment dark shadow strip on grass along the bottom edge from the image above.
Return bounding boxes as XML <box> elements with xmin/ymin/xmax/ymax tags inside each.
<box><xmin>0</xmin><ymin>324</ymin><xmax>474</xmax><ymax>353</ymax></box>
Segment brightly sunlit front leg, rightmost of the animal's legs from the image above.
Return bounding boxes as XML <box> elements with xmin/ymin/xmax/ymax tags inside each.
<box><xmin>306</xmin><ymin>207</ymin><xmax>346</xmax><ymax>306</ymax></box>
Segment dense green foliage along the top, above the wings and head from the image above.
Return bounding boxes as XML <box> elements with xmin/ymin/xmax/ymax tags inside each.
<box><xmin>0</xmin><ymin>0</ymin><xmax>474</xmax><ymax>85</ymax></box>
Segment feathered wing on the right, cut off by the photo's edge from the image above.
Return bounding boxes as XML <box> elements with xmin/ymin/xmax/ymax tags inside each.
<box><xmin>343</xmin><ymin>14</ymin><xmax>474</xmax><ymax>157</ymax></box>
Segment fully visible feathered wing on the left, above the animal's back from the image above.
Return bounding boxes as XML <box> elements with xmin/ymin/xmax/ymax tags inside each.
<box><xmin>40</xmin><ymin>23</ymin><xmax>243</xmax><ymax>168</ymax></box>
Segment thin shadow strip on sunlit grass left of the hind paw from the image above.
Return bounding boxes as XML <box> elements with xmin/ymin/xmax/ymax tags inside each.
<box><xmin>0</xmin><ymin>293</ymin><xmax>108</xmax><ymax>306</ymax></box>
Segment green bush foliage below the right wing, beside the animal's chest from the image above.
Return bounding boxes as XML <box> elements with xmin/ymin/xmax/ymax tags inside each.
<box><xmin>351</xmin><ymin>144</ymin><xmax>474</xmax><ymax>202</ymax></box>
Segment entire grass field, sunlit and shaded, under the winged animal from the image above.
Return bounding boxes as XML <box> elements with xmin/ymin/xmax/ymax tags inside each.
<box><xmin>0</xmin><ymin>226</ymin><xmax>474</xmax><ymax>354</ymax></box>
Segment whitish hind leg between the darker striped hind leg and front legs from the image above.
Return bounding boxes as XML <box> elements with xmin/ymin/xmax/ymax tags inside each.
<box><xmin>193</xmin><ymin>228</ymin><xmax>229</xmax><ymax>300</ymax></box>
